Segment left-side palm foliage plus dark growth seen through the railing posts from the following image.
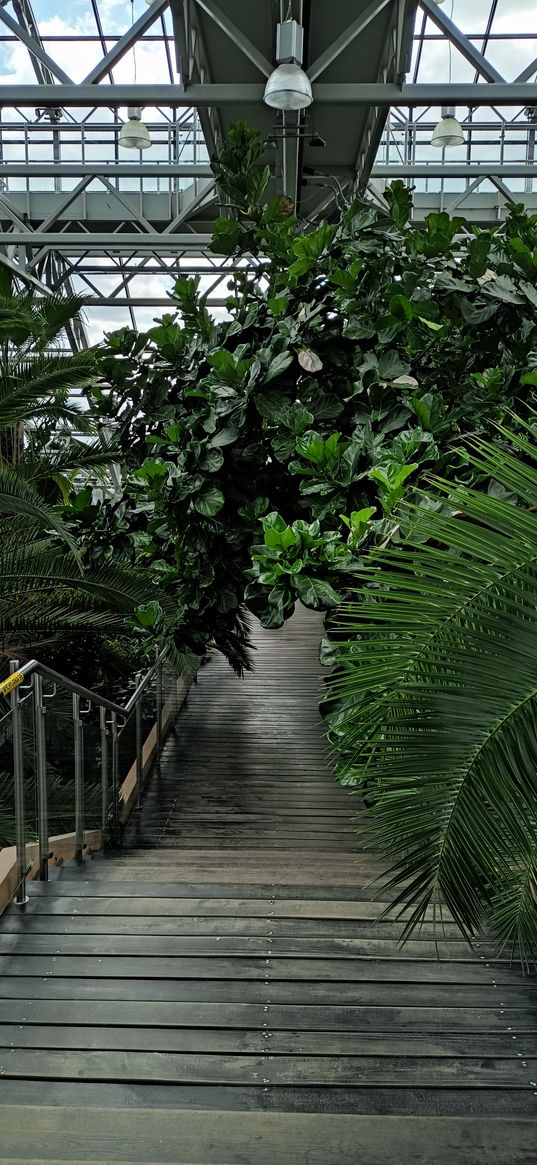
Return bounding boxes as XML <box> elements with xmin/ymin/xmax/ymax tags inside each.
<box><xmin>0</xmin><ymin>285</ymin><xmax>165</xmax><ymax>847</ymax></box>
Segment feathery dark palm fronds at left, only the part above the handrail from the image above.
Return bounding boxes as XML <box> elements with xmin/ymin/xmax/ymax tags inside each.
<box><xmin>0</xmin><ymin>283</ymin><xmax>158</xmax><ymax>657</ymax></box>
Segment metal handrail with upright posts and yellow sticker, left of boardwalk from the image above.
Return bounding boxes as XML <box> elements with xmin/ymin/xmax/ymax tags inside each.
<box><xmin>0</xmin><ymin>648</ymin><xmax>169</xmax><ymax>905</ymax></box>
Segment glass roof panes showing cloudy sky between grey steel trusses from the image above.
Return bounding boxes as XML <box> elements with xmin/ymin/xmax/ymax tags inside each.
<box><xmin>0</xmin><ymin>0</ymin><xmax>537</xmax><ymax>340</ymax></box>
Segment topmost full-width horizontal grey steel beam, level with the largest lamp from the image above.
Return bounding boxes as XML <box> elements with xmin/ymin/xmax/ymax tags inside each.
<box><xmin>0</xmin><ymin>82</ymin><xmax>537</xmax><ymax>108</ymax></box>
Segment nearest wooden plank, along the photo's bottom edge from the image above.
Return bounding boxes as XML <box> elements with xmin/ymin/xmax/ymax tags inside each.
<box><xmin>2</xmin><ymin>1104</ymin><xmax>536</xmax><ymax>1165</ymax></box>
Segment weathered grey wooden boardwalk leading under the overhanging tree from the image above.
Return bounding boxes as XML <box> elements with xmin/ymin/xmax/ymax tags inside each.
<box><xmin>0</xmin><ymin>612</ymin><xmax>537</xmax><ymax>1165</ymax></box>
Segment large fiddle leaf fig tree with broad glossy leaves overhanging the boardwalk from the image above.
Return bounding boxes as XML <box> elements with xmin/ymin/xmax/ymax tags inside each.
<box><xmin>72</xmin><ymin>123</ymin><xmax>537</xmax><ymax>670</ymax></box>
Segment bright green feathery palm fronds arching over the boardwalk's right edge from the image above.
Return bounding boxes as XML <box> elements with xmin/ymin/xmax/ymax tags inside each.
<box><xmin>331</xmin><ymin>428</ymin><xmax>537</xmax><ymax>963</ymax></box>
